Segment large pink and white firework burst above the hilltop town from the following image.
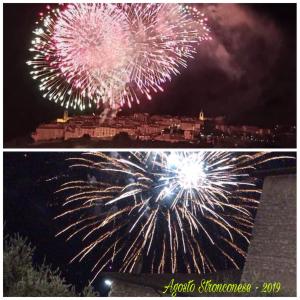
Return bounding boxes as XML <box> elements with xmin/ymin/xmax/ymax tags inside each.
<box><xmin>27</xmin><ymin>3</ymin><xmax>210</xmax><ymax>110</ymax></box>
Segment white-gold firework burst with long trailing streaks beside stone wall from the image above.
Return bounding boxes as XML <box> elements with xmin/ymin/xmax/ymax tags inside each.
<box><xmin>57</xmin><ymin>152</ymin><xmax>289</xmax><ymax>280</ymax></box>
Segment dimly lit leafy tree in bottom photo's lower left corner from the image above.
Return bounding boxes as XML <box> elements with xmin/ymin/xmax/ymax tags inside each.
<box><xmin>3</xmin><ymin>234</ymin><xmax>99</xmax><ymax>297</ymax></box>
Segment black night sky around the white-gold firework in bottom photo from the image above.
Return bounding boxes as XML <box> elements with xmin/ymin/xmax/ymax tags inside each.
<box><xmin>4</xmin><ymin>152</ymin><xmax>296</xmax><ymax>292</ymax></box>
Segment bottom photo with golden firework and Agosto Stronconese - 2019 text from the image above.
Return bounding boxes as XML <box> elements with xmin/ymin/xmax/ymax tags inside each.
<box><xmin>3</xmin><ymin>150</ymin><xmax>297</xmax><ymax>297</ymax></box>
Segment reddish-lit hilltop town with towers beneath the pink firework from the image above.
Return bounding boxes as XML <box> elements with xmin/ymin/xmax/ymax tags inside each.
<box><xmin>27</xmin><ymin>111</ymin><xmax>295</xmax><ymax>147</ymax></box>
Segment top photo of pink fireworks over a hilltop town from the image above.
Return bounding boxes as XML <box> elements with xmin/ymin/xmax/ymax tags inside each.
<box><xmin>3</xmin><ymin>3</ymin><xmax>297</xmax><ymax>149</ymax></box>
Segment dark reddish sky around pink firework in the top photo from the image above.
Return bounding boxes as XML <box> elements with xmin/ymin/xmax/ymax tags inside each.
<box><xmin>4</xmin><ymin>4</ymin><xmax>296</xmax><ymax>141</ymax></box>
